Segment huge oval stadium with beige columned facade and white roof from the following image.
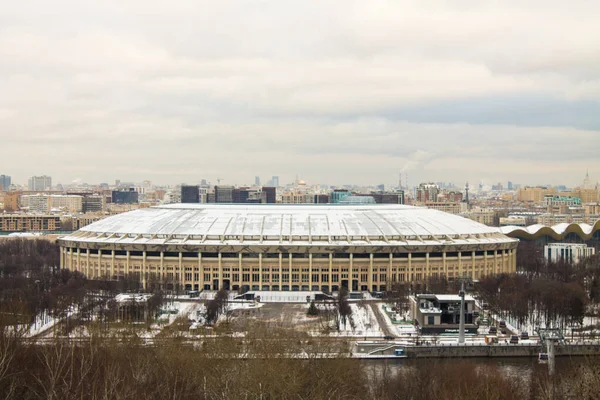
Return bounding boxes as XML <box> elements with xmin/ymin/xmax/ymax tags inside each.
<box><xmin>59</xmin><ymin>204</ymin><xmax>518</xmax><ymax>292</ymax></box>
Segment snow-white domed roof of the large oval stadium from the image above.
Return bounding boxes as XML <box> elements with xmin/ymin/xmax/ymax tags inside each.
<box><xmin>61</xmin><ymin>204</ymin><xmax>515</xmax><ymax>246</ymax></box>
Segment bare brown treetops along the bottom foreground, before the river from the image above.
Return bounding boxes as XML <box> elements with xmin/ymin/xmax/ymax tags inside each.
<box><xmin>0</xmin><ymin>327</ymin><xmax>600</xmax><ymax>400</ymax></box>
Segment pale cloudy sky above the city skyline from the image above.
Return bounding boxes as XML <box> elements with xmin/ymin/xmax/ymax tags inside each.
<box><xmin>0</xmin><ymin>0</ymin><xmax>600</xmax><ymax>186</ymax></box>
